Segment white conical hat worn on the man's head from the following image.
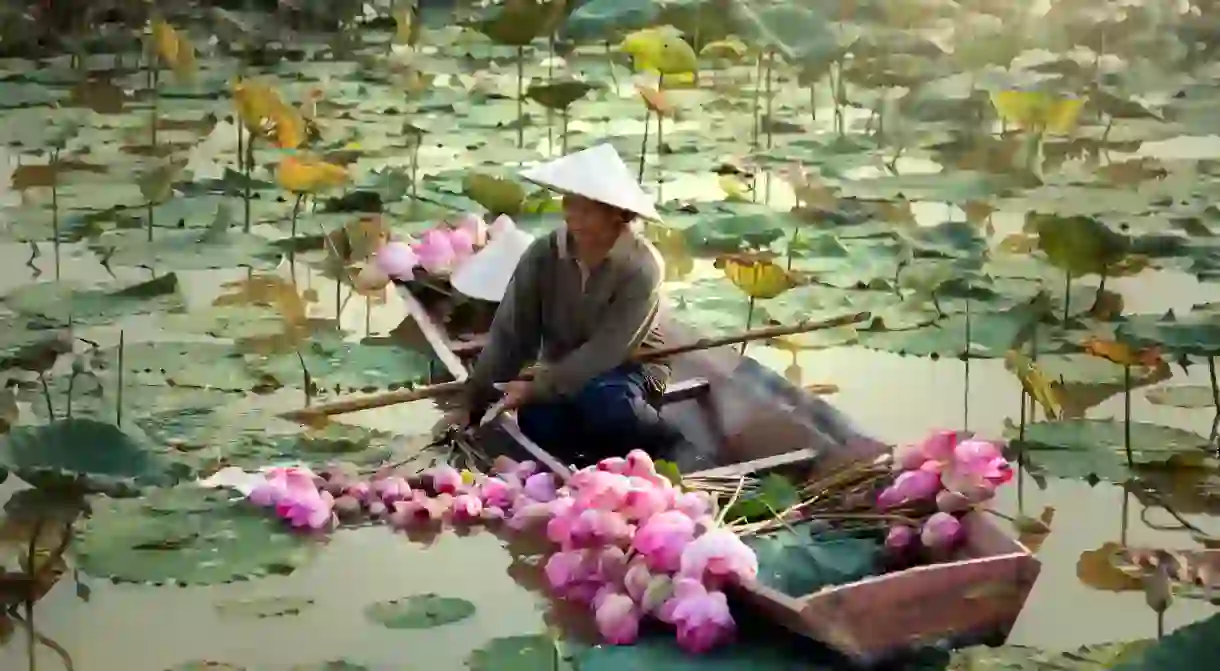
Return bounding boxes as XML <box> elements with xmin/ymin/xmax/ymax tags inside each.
<box><xmin>521</xmin><ymin>144</ymin><xmax>661</xmax><ymax>221</ymax></box>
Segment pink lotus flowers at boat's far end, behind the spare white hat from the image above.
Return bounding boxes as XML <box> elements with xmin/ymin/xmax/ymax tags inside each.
<box><xmin>375</xmin><ymin>212</ymin><xmax>516</xmax><ymax>281</ymax></box>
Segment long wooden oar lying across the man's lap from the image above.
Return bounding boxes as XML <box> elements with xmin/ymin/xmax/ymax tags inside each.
<box><xmin>282</xmin><ymin>312</ymin><xmax>872</xmax><ymax>421</ymax></box>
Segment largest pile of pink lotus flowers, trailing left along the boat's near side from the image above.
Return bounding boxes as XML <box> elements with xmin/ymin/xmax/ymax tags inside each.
<box><xmin>248</xmin><ymin>450</ymin><xmax>758</xmax><ymax>653</ymax></box>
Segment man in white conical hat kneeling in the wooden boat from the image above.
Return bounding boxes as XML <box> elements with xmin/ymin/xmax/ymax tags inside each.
<box><xmin>439</xmin><ymin>144</ymin><xmax>684</xmax><ymax>461</ymax></box>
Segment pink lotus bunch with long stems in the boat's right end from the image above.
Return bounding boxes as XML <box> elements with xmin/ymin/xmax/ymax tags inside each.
<box><xmin>876</xmin><ymin>431</ymin><xmax>1013</xmax><ymax>555</ymax></box>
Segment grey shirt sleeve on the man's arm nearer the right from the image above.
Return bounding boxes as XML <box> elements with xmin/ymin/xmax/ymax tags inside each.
<box><xmin>532</xmin><ymin>263</ymin><xmax>660</xmax><ymax>399</ymax></box>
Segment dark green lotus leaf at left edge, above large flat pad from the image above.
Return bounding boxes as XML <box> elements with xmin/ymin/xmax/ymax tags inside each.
<box><xmin>0</xmin><ymin>418</ymin><xmax>185</xmax><ymax>495</ymax></box>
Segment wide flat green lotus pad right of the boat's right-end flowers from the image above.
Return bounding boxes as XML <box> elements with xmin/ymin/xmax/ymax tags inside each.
<box><xmin>1005</xmin><ymin>420</ymin><xmax>1208</xmax><ymax>482</ymax></box>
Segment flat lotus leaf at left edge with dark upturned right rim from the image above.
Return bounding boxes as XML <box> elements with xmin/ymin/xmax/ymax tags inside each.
<box><xmin>4</xmin><ymin>273</ymin><xmax>184</xmax><ymax>326</ymax></box>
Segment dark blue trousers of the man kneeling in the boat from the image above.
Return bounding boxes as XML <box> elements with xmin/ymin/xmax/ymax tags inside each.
<box><xmin>517</xmin><ymin>364</ymin><xmax>686</xmax><ymax>465</ymax></box>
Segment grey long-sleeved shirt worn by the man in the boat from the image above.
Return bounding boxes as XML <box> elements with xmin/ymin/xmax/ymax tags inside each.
<box><xmin>467</xmin><ymin>227</ymin><xmax>665</xmax><ymax>403</ymax></box>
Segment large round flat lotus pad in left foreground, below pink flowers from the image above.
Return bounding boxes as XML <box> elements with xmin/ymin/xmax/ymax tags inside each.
<box><xmin>76</xmin><ymin>486</ymin><xmax>317</xmax><ymax>584</ymax></box>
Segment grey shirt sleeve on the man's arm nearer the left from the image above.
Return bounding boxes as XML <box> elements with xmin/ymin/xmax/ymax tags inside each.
<box><xmin>466</xmin><ymin>238</ymin><xmax>549</xmax><ymax>411</ymax></box>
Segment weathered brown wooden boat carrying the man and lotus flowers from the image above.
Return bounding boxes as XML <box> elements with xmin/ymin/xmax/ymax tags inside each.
<box><xmin>398</xmin><ymin>282</ymin><xmax>1041</xmax><ymax>665</ymax></box>
